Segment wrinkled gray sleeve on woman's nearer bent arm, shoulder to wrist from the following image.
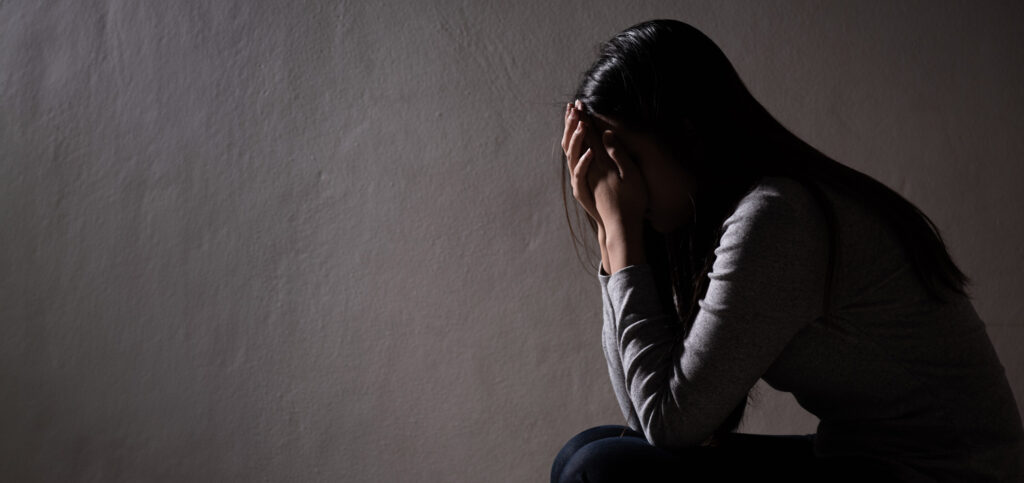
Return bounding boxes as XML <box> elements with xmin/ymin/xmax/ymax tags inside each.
<box><xmin>606</xmin><ymin>179</ymin><xmax>828</xmax><ymax>450</ymax></box>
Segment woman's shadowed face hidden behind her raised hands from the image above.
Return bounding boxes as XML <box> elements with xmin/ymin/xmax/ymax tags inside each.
<box><xmin>593</xmin><ymin>114</ymin><xmax>696</xmax><ymax>233</ymax></box>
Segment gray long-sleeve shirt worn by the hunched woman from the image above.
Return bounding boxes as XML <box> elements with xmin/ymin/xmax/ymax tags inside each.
<box><xmin>598</xmin><ymin>177</ymin><xmax>1024</xmax><ymax>481</ymax></box>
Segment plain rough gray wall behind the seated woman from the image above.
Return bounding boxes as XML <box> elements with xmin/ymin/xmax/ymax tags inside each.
<box><xmin>0</xmin><ymin>0</ymin><xmax>1024</xmax><ymax>482</ymax></box>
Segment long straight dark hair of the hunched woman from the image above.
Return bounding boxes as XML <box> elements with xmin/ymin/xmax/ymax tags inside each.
<box><xmin>562</xmin><ymin>19</ymin><xmax>970</xmax><ymax>446</ymax></box>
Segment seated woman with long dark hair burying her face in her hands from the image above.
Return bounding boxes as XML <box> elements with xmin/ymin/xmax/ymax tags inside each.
<box><xmin>552</xmin><ymin>19</ymin><xmax>1024</xmax><ymax>482</ymax></box>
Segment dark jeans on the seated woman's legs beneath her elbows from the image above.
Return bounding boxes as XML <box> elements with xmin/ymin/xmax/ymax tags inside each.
<box><xmin>551</xmin><ymin>426</ymin><xmax>888</xmax><ymax>483</ymax></box>
